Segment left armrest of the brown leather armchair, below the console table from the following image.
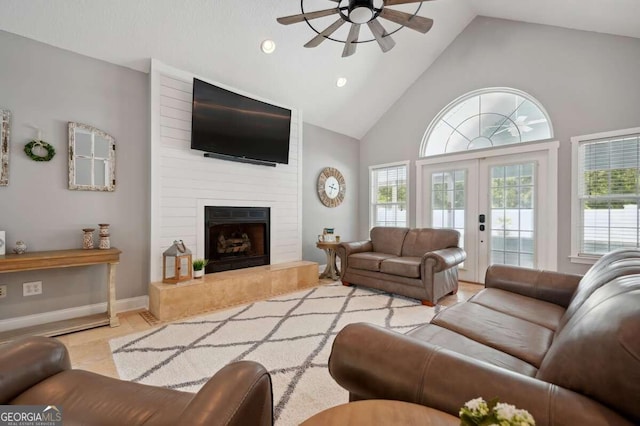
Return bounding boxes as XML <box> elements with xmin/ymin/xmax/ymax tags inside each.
<box><xmin>0</xmin><ymin>337</ymin><xmax>71</xmax><ymax>404</ymax></box>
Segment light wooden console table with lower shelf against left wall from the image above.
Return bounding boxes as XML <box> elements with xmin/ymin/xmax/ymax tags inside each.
<box><xmin>0</xmin><ymin>248</ymin><xmax>121</xmax><ymax>343</ymax></box>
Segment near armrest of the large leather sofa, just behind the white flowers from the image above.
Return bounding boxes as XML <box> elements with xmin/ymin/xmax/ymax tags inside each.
<box><xmin>329</xmin><ymin>323</ymin><xmax>631</xmax><ymax>426</ymax></box>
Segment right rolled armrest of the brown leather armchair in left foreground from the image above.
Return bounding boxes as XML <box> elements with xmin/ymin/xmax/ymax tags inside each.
<box><xmin>180</xmin><ymin>361</ymin><xmax>273</xmax><ymax>426</ymax></box>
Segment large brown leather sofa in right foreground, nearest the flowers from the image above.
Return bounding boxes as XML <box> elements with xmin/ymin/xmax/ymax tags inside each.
<box><xmin>329</xmin><ymin>249</ymin><xmax>640</xmax><ymax>426</ymax></box>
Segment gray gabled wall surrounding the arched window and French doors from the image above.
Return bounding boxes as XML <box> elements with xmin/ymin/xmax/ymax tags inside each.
<box><xmin>359</xmin><ymin>17</ymin><xmax>640</xmax><ymax>272</ymax></box>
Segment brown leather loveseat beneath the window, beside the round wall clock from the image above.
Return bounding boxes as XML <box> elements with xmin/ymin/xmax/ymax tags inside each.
<box><xmin>337</xmin><ymin>227</ymin><xmax>467</xmax><ymax>306</ymax></box>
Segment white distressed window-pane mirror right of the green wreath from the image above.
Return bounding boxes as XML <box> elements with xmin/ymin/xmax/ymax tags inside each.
<box><xmin>69</xmin><ymin>122</ymin><xmax>116</xmax><ymax>191</ymax></box>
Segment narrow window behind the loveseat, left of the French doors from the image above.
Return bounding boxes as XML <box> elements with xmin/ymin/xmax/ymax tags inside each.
<box><xmin>370</xmin><ymin>163</ymin><xmax>408</xmax><ymax>227</ymax></box>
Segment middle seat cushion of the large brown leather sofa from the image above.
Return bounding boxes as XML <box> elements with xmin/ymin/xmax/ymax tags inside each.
<box><xmin>431</xmin><ymin>303</ymin><xmax>553</xmax><ymax>368</ymax></box>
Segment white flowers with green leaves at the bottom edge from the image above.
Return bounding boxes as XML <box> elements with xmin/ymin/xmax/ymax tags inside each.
<box><xmin>458</xmin><ymin>398</ymin><xmax>536</xmax><ymax>426</ymax></box>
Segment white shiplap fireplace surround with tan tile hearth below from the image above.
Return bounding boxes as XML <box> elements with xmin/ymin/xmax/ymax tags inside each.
<box><xmin>149</xmin><ymin>60</ymin><xmax>318</xmax><ymax>320</ymax></box>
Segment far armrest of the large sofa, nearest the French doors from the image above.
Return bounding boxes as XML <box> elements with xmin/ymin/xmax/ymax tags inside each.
<box><xmin>484</xmin><ymin>265</ymin><xmax>582</xmax><ymax>308</ymax></box>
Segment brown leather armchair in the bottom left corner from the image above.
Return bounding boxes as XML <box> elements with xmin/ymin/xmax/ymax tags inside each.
<box><xmin>0</xmin><ymin>337</ymin><xmax>273</xmax><ymax>426</ymax></box>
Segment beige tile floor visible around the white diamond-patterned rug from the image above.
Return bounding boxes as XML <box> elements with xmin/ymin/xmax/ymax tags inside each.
<box><xmin>57</xmin><ymin>280</ymin><xmax>482</xmax><ymax>378</ymax></box>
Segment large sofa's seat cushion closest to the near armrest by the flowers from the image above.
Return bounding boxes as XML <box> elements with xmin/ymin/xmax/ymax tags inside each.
<box><xmin>407</xmin><ymin>324</ymin><xmax>538</xmax><ymax>377</ymax></box>
